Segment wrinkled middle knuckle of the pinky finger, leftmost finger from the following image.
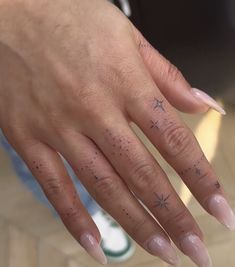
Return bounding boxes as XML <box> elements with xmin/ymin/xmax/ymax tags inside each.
<box><xmin>42</xmin><ymin>178</ymin><xmax>64</xmax><ymax>197</ymax></box>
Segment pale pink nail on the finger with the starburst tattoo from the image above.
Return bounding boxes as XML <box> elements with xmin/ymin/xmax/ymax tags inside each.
<box><xmin>180</xmin><ymin>234</ymin><xmax>212</xmax><ymax>267</ymax></box>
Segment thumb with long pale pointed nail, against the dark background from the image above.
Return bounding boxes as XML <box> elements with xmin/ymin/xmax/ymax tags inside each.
<box><xmin>135</xmin><ymin>29</ymin><xmax>225</xmax><ymax>114</ymax></box>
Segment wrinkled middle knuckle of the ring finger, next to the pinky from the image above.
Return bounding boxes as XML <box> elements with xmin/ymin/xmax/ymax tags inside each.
<box><xmin>94</xmin><ymin>175</ymin><xmax>119</xmax><ymax>198</ymax></box>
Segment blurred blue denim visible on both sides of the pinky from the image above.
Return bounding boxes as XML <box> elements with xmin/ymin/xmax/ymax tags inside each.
<box><xmin>0</xmin><ymin>129</ymin><xmax>100</xmax><ymax>218</ymax></box>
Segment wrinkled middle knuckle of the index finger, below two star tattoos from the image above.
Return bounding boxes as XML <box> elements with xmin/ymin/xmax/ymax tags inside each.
<box><xmin>162</xmin><ymin>125</ymin><xmax>193</xmax><ymax>156</ymax></box>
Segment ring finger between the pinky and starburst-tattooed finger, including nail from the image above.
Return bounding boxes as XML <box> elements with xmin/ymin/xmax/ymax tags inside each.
<box><xmin>51</xmin><ymin>131</ymin><xmax>182</xmax><ymax>265</ymax></box>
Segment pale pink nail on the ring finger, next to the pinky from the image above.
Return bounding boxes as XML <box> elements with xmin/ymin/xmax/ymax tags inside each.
<box><xmin>145</xmin><ymin>235</ymin><xmax>180</xmax><ymax>266</ymax></box>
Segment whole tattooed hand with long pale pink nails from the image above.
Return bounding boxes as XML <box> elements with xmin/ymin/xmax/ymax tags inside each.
<box><xmin>0</xmin><ymin>0</ymin><xmax>231</xmax><ymax>267</ymax></box>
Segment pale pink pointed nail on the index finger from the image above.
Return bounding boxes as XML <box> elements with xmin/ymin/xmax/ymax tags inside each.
<box><xmin>208</xmin><ymin>195</ymin><xmax>235</xmax><ymax>230</ymax></box>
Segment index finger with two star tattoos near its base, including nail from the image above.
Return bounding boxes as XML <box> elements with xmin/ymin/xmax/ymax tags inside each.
<box><xmin>127</xmin><ymin>85</ymin><xmax>235</xmax><ymax>230</ymax></box>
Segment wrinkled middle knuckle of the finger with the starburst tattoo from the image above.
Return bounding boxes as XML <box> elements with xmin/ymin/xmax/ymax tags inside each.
<box><xmin>131</xmin><ymin>162</ymin><xmax>156</xmax><ymax>192</ymax></box>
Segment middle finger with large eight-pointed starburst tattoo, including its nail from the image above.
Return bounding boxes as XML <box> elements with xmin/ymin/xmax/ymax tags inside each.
<box><xmin>81</xmin><ymin>112</ymin><xmax>210</xmax><ymax>266</ymax></box>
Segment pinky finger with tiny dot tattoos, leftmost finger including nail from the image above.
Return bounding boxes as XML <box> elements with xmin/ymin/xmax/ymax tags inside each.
<box><xmin>7</xmin><ymin>136</ymin><xmax>107</xmax><ymax>264</ymax></box>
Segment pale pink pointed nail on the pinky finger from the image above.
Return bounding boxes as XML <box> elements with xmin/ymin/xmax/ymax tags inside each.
<box><xmin>80</xmin><ymin>233</ymin><xmax>107</xmax><ymax>264</ymax></box>
